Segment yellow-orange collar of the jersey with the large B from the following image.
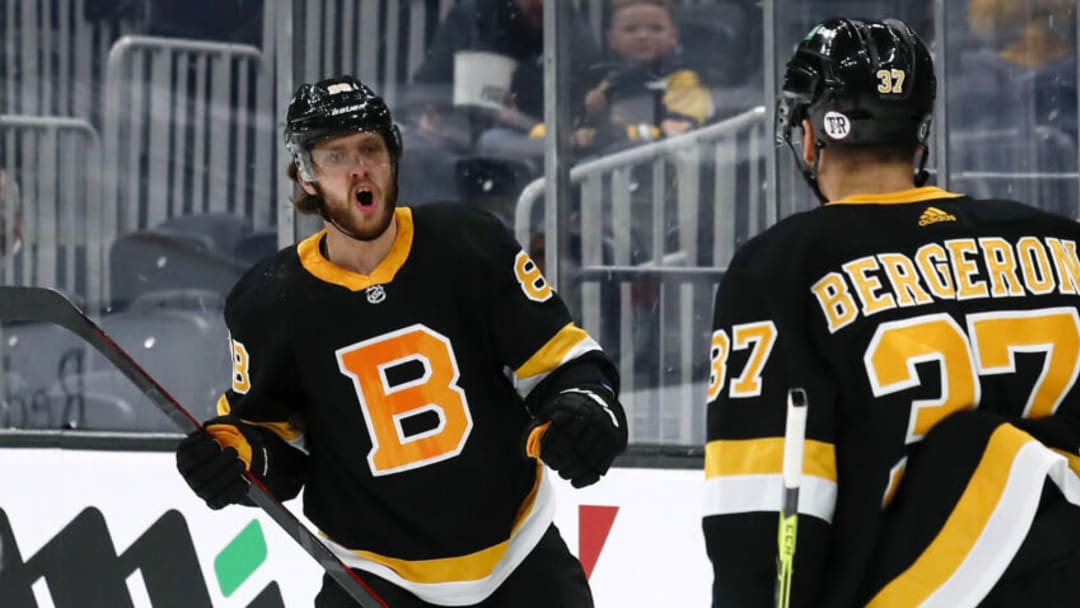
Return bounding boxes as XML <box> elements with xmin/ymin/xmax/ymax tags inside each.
<box><xmin>296</xmin><ymin>207</ymin><xmax>413</xmax><ymax>292</ymax></box>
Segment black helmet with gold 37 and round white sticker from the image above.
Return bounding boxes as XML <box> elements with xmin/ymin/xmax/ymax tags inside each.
<box><xmin>775</xmin><ymin>18</ymin><xmax>937</xmax><ymax>201</ymax></box>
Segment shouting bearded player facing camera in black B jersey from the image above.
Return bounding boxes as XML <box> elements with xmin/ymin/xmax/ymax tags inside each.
<box><xmin>169</xmin><ymin>77</ymin><xmax>626</xmax><ymax>608</ymax></box>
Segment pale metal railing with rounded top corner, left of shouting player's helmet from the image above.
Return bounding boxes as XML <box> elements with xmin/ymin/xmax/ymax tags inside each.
<box><xmin>102</xmin><ymin>36</ymin><xmax>280</xmax><ymax>306</ymax></box>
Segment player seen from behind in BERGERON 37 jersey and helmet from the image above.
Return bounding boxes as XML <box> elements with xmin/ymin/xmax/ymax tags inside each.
<box><xmin>703</xmin><ymin>18</ymin><xmax>1080</xmax><ymax>608</ymax></box>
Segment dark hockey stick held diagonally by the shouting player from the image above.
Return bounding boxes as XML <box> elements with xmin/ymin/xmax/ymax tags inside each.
<box><xmin>0</xmin><ymin>286</ymin><xmax>388</xmax><ymax>608</ymax></box>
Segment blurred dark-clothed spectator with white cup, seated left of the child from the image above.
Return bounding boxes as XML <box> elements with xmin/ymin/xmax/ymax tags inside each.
<box><xmin>413</xmin><ymin>0</ymin><xmax>599</xmax><ymax>145</ymax></box>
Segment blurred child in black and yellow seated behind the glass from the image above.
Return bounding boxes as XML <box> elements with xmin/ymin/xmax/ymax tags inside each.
<box><xmin>573</xmin><ymin>0</ymin><xmax>713</xmax><ymax>148</ymax></box>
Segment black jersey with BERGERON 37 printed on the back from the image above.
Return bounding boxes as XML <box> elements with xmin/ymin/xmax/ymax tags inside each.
<box><xmin>703</xmin><ymin>187</ymin><xmax>1080</xmax><ymax>607</ymax></box>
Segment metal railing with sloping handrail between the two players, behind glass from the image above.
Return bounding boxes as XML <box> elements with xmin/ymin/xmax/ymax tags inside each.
<box><xmin>514</xmin><ymin>107</ymin><xmax>770</xmax><ymax>444</ymax></box>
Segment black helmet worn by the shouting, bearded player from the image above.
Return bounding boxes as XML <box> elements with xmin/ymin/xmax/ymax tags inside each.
<box><xmin>285</xmin><ymin>76</ymin><xmax>402</xmax><ymax>181</ymax></box>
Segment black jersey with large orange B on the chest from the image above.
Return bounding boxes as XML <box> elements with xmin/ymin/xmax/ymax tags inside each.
<box><xmin>219</xmin><ymin>205</ymin><xmax>599</xmax><ymax>605</ymax></box>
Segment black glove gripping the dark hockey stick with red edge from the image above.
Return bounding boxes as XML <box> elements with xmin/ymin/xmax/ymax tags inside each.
<box><xmin>176</xmin><ymin>416</ymin><xmax>265</xmax><ymax>510</ymax></box>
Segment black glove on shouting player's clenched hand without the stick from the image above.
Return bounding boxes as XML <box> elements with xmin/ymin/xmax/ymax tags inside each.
<box><xmin>526</xmin><ymin>387</ymin><xmax>626</xmax><ymax>488</ymax></box>
